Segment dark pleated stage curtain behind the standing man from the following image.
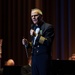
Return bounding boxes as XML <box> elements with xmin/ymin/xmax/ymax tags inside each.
<box><xmin>0</xmin><ymin>0</ymin><xmax>75</xmax><ymax>66</ymax></box>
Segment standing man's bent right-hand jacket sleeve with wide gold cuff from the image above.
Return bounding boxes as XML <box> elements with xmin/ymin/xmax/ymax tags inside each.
<box><xmin>37</xmin><ymin>26</ymin><xmax>54</xmax><ymax>46</ymax></box>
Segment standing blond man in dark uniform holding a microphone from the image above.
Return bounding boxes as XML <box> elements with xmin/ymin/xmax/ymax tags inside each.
<box><xmin>22</xmin><ymin>8</ymin><xmax>54</xmax><ymax>75</ymax></box>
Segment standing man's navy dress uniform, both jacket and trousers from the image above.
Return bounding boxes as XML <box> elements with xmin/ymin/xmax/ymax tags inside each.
<box><xmin>27</xmin><ymin>22</ymin><xmax>54</xmax><ymax>75</ymax></box>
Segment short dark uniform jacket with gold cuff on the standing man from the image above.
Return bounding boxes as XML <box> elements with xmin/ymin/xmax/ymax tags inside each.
<box><xmin>31</xmin><ymin>22</ymin><xmax>54</xmax><ymax>55</ymax></box>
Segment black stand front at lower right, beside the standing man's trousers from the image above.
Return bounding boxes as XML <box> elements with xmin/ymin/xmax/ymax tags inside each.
<box><xmin>51</xmin><ymin>60</ymin><xmax>75</xmax><ymax>75</ymax></box>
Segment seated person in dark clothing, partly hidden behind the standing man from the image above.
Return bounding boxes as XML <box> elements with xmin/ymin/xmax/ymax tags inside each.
<box><xmin>21</xmin><ymin>56</ymin><xmax>32</xmax><ymax>75</ymax></box>
